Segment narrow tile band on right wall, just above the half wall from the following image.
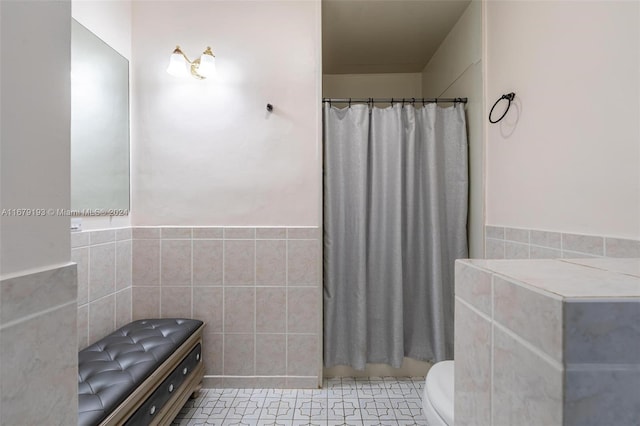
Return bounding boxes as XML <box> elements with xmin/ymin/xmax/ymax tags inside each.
<box><xmin>485</xmin><ymin>225</ymin><xmax>640</xmax><ymax>259</ymax></box>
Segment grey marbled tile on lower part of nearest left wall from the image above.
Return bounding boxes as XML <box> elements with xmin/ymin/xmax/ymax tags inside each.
<box><xmin>0</xmin><ymin>264</ymin><xmax>78</xmax><ymax>425</ymax></box>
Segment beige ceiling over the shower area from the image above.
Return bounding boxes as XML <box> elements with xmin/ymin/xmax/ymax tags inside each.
<box><xmin>322</xmin><ymin>0</ymin><xmax>471</xmax><ymax>74</ymax></box>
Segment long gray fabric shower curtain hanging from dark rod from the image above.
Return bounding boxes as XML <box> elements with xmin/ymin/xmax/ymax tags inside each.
<box><xmin>323</xmin><ymin>104</ymin><xmax>468</xmax><ymax>369</ymax></box>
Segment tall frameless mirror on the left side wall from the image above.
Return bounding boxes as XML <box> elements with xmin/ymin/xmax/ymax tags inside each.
<box><xmin>71</xmin><ymin>20</ymin><xmax>129</xmax><ymax>215</ymax></box>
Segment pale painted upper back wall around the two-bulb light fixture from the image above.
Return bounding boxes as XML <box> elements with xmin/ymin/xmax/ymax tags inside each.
<box><xmin>132</xmin><ymin>1</ymin><xmax>321</xmax><ymax>226</ymax></box>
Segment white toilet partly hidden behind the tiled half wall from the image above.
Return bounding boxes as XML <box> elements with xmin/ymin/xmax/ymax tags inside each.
<box><xmin>422</xmin><ymin>361</ymin><xmax>453</xmax><ymax>426</ymax></box>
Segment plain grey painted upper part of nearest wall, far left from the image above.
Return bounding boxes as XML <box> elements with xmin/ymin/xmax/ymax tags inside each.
<box><xmin>0</xmin><ymin>7</ymin><xmax>70</xmax><ymax>276</ymax></box>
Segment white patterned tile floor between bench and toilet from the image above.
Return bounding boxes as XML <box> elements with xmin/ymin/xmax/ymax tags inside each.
<box><xmin>173</xmin><ymin>377</ymin><xmax>427</xmax><ymax>426</ymax></box>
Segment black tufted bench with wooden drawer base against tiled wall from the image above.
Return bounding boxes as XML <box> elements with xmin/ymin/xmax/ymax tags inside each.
<box><xmin>78</xmin><ymin>318</ymin><xmax>204</xmax><ymax>426</ymax></box>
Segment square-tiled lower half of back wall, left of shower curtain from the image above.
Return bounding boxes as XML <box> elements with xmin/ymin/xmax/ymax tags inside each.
<box><xmin>132</xmin><ymin>227</ymin><xmax>321</xmax><ymax>388</ymax></box>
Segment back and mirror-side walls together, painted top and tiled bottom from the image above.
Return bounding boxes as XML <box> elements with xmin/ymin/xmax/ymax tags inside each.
<box><xmin>72</xmin><ymin>1</ymin><xmax>321</xmax><ymax>387</ymax></box>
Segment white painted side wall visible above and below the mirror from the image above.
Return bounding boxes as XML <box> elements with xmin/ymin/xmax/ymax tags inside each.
<box><xmin>71</xmin><ymin>0</ymin><xmax>135</xmax><ymax>230</ymax></box>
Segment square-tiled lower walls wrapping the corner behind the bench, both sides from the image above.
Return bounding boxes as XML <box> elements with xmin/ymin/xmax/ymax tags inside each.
<box><xmin>71</xmin><ymin>227</ymin><xmax>322</xmax><ymax>387</ymax></box>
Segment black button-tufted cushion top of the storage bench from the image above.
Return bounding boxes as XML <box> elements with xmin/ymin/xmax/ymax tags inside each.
<box><xmin>78</xmin><ymin>318</ymin><xmax>202</xmax><ymax>425</ymax></box>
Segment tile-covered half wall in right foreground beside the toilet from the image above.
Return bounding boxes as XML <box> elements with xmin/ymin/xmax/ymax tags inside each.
<box><xmin>455</xmin><ymin>258</ymin><xmax>640</xmax><ymax>426</ymax></box>
